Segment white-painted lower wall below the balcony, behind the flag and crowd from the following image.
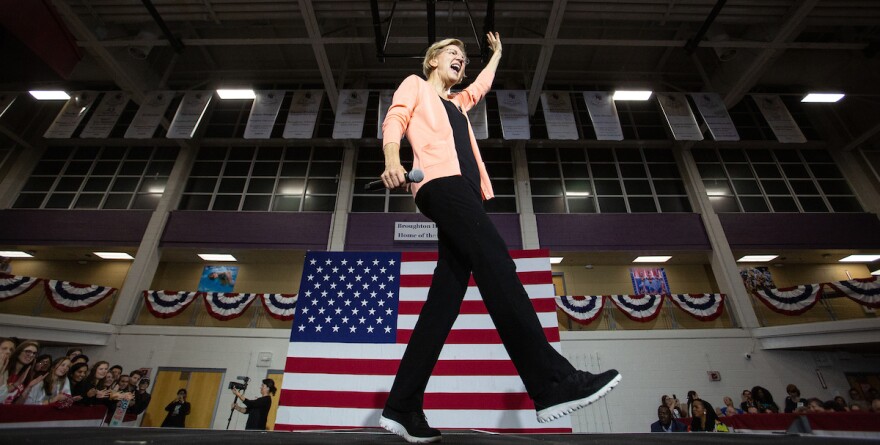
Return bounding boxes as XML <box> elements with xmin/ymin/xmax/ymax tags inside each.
<box><xmin>39</xmin><ymin>326</ymin><xmax>880</xmax><ymax>432</ymax></box>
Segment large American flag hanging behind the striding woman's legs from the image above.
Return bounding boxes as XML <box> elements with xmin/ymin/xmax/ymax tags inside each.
<box><xmin>275</xmin><ymin>250</ymin><xmax>571</xmax><ymax>433</ymax></box>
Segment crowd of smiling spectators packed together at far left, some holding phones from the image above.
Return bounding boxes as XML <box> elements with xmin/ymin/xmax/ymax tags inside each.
<box><xmin>0</xmin><ymin>338</ymin><xmax>151</xmax><ymax>421</ymax></box>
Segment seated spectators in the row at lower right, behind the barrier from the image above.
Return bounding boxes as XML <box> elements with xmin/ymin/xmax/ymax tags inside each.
<box><xmin>651</xmin><ymin>384</ymin><xmax>880</xmax><ymax>433</ymax></box>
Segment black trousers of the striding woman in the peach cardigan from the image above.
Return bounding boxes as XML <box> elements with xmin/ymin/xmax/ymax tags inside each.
<box><xmin>387</xmin><ymin>176</ymin><xmax>575</xmax><ymax>411</ymax></box>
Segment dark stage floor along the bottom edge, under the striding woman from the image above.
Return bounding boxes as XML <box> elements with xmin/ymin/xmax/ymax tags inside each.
<box><xmin>0</xmin><ymin>427</ymin><xmax>877</xmax><ymax>445</ymax></box>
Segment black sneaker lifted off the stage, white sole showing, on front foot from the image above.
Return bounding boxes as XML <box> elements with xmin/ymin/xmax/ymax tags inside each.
<box><xmin>535</xmin><ymin>369</ymin><xmax>620</xmax><ymax>423</ymax></box>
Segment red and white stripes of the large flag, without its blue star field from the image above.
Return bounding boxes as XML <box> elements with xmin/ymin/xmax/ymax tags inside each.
<box><xmin>275</xmin><ymin>250</ymin><xmax>571</xmax><ymax>433</ymax></box>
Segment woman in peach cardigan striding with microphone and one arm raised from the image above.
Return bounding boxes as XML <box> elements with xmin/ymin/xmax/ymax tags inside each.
<box><xmin>379</xmin><ymin>33</ymin><xmax>620</xmax><ymax>443</ymax></box>
